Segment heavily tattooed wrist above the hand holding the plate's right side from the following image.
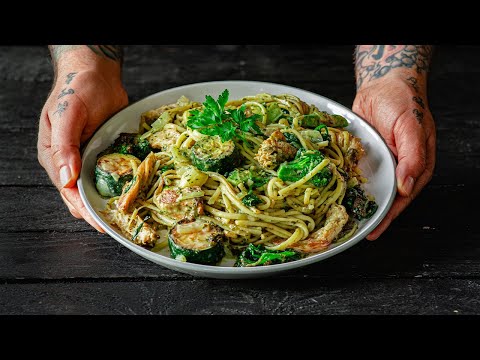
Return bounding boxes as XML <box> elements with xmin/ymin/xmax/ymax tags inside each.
<box><xmin>355</xmin><ymin>45</ymin><xmax>433</xmax><ymax>93</ymax></box>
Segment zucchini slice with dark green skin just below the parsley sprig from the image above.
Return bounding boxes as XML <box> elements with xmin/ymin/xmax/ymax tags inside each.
<box><xmin>191</xmin><ymin>135</ymin><xmax>242</xmax><ymax>174</ymax></box>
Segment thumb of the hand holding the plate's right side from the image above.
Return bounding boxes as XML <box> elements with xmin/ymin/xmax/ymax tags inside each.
<box><xmin>395</xmin><ymin>114</ymin><xmax>427</xmax><ymax>196</ymax></box>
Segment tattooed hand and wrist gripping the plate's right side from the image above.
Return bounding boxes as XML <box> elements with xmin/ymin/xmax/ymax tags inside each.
<box><xmin>353</xmin><ymin>45</ymin><xmax>436</xmax><ymax>240</ymax></box>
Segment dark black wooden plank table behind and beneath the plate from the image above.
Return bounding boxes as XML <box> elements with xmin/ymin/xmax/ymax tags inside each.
<box><xmin>0</xmin><ymin>45</ymin><xmax>480</xmax><ymax>315</ymax></box>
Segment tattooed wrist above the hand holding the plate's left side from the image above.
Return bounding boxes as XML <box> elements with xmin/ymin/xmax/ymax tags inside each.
<box><xmin>49</xmin><ymin>45</ymin><xmax>123</xmax><ymax>82</ymax></box>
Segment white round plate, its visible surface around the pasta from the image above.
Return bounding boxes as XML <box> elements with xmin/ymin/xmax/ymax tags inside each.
<box><xmin>78</xmin><ymin>81</ymin><xmax>396</xmax><ymax>279</ymax></box>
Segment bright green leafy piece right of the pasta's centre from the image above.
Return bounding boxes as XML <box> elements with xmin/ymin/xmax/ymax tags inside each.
<box><xmin>278</xmin><ymin>149</ymin><xmax>333</xmax><ymax>187</ymax></box>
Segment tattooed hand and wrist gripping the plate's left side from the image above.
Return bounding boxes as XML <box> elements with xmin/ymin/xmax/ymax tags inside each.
<box><xmin>37</xmin><ymin>45</ymin><xmax>128</xmax><ymax>232</ymax></box>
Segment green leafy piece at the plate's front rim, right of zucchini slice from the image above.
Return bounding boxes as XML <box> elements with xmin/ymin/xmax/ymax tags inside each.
<box><xmin>234</xmin><ymin>244</ymin><xmax>303</xmax><ymax>267</ymax></box>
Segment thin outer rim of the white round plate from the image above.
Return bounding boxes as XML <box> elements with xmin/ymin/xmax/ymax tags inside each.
<box><xmin>77</xmin><ymin>80</ymin><xmax>397</xmax><ymax>279</ymax></box>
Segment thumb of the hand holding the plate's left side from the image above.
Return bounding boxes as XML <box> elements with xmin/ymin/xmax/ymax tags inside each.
<box><xmin>49</xmin><ymin>97</ymin><xmax>86</xmax><ymax>189</ymax></box>
